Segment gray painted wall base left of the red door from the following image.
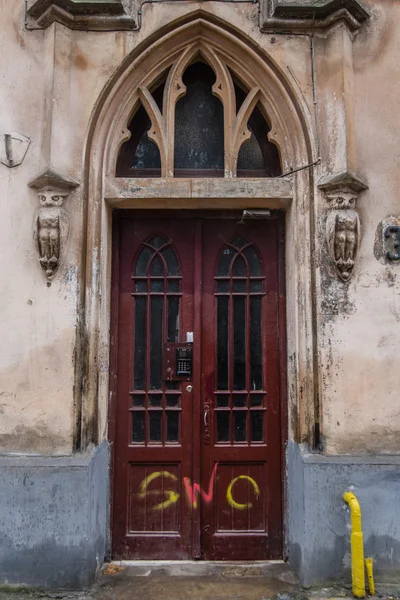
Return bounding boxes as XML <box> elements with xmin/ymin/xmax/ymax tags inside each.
<box><xmin>0</xmin><ymin>442</ymin><xmax>109</xmax><ymax>588</ymax></box>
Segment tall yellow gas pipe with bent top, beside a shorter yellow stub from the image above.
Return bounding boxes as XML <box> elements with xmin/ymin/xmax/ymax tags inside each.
<box><xmin>343</xmin><ymin>492</ymin><xmax>365</xmax><ymax>598</ymax></box>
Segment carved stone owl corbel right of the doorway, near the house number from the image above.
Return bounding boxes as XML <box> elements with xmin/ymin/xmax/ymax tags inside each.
<box><xmin>318</xmin><ymin>173</ymin><xmax>368</xmax><ymax>282</ymax></box>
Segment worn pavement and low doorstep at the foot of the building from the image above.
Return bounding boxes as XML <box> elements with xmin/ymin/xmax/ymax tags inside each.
<box><xmin>0</xmin><ymin>561</ymin><xmax>400</xmax><ymax>600</ymax></box>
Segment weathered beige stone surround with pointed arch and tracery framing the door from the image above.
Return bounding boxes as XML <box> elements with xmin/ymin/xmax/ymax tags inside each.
<box><xmin>82</xmin><ymin>15</ymin><xmax>315</xmax><ymax>447</ymax></box>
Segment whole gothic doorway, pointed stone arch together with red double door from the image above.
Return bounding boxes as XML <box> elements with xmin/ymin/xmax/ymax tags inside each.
<box><xmin>84</xmin><ymin>14</ymin><xmax>312</xmax><ymax>560</ymax></box>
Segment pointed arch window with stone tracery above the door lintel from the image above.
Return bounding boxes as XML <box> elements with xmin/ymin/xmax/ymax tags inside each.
<box><xmin>116</xmin><ymin>49</ymin><xmax>282</xmax><ymax>178</ymax></box>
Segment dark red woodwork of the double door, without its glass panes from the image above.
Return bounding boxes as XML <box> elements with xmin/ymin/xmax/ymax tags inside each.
<box><xmin>109</xmin><ymin>211</ymin><xmax>286</xmax><ymax>560</ymax></box>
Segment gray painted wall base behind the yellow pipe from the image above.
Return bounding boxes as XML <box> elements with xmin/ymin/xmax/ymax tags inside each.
<box><xmin>286</xmin><ymin>442</ymin><xmax>400</xmax><ymax>585</ymax></box>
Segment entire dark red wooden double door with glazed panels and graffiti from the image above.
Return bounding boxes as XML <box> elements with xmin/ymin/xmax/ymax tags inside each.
<box><xmin>110</xmin><ymin>213</ymin><xmax>285</xmax><ymax>560</ymax></box>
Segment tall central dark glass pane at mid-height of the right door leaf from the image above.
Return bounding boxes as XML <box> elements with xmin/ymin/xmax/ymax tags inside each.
<box><xmin>233</xmin><ymin>296</ymin><xmax>245</xmax><ymax>390</ymax></box>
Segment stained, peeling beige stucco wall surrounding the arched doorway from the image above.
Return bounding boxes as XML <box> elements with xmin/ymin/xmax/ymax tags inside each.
<box><xmin>0</xmin><ymin>0</ymin><xmax>400</xmax><ymax>454</ymax></box>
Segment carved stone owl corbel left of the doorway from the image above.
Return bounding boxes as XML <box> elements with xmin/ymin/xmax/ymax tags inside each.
<box><xmin>28</xmin><ymin>169</ymin><xmax>79</xmax><ymax>280</ymax></box>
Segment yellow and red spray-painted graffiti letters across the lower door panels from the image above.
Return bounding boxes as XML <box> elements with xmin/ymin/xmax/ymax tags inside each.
<box><xmin>137</xmin><ymin>463</ymin><xmax>260</xmax><ymax>510</ymax></box>
